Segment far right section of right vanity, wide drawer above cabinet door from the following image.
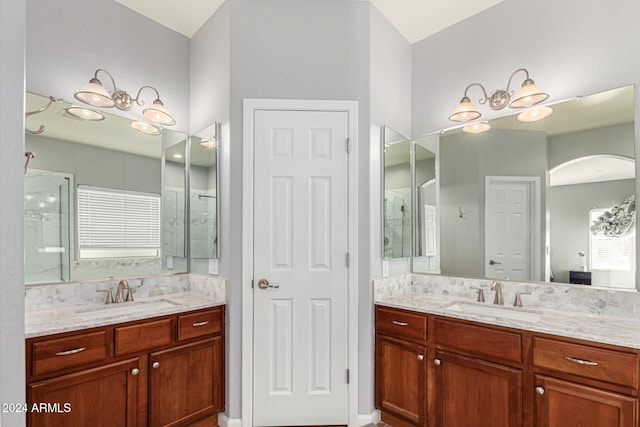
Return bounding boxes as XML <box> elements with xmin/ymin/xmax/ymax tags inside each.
<box><xmin>533</xmin><ymin>336</ymin><xmax>639</xmax><ymax>427</ymax></box>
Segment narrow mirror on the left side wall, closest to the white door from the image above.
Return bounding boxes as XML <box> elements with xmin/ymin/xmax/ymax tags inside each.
<box><xmin>189</xmin><ymin>123</ymin><xmax>219</xmax><ymax>274</ymax></box>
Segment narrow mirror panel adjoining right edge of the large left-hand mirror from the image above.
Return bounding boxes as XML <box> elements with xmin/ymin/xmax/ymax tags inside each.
<box><xmin>162</xmin><ymin>135</ymin><xmax>188</xmax><ymax>271</ymax></box>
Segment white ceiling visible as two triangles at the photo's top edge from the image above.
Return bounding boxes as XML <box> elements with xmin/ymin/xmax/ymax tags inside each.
<box><xmin>115</xmin><ymin>0</ymin><xmax>504</xmax><ymax>44</ymax></box>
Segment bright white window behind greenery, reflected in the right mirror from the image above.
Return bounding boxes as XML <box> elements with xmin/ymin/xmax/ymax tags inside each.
<box><xmin>589</xmin><ymin>209</ymin><xmax>636</xmax><ymax>271</ymax></box>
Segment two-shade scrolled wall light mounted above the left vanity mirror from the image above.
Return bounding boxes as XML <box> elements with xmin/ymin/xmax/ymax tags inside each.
<box><xmin>74</xmin><ymin>68</ymin><xmax>176</xmax><ymax>126</ymax></box>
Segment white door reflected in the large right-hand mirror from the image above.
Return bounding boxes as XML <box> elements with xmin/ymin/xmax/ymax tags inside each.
<box><xmin>485</xmin><ymin>177</ymin><xmax>539</xmax><ymax>280</ymax></box>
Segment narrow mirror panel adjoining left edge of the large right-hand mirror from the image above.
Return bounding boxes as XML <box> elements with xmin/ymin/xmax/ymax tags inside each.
<box><xmin>412</xmin><ymin>135</ymin><xmax>440</xmax><ymax>273</ymax></box>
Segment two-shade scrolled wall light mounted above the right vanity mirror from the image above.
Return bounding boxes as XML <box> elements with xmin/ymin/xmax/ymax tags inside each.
<box><xmin>449</xmin><ymin>68</ymin><xmax>549</xmax><ymax>122</ymax></box>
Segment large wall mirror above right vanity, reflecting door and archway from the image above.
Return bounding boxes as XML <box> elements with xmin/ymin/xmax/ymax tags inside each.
<box><xmin>414</xmin><ymin>86</ymin><xmax>636</xmax><ymax>289</ymax></box>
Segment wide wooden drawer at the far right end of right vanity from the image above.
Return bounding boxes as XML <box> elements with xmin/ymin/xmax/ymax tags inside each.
<box><xmin>533</xmin><ymin>337</ymin><xmax>638</xmax><ymax>388</ymax></box>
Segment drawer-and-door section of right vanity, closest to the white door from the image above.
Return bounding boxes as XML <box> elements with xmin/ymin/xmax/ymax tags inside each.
<box><xmin>375</xmin><ymin>307</ymin><xmax>427</xmax><ymax>427</ymax></box>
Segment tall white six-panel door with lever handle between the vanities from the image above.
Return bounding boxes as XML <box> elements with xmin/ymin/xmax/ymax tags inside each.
<box><xmin>253</xmin><ymin>110</ymin><xmax>349</xmax><ymax>426</ymax></box>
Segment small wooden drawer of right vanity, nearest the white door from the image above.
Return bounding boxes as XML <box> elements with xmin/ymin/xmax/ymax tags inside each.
<box><xmin>376</xmin><ymin>307</ymin><xmax>427</xmax><ymax>341</ymax></box>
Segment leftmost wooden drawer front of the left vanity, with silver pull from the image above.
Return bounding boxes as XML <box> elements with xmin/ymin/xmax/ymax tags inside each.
<box><xmin>31</xmin><ymin>331</ymin><xmax>107</xmax><ymax>375</ymax></box>
